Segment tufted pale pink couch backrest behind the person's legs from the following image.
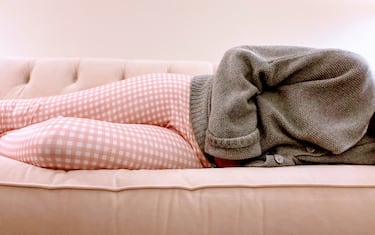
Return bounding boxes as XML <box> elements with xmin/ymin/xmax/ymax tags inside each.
<box><xmin>0</xmin><ymin>58</ymin><xmax>216</xmax><ymax>99</ymax></box>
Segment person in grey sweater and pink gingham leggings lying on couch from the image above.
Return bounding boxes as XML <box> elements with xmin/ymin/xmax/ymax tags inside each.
<box><xmin>0</xmin><ymin>46</ymin><xmax>375</xmax><ymax>170</ymax></box>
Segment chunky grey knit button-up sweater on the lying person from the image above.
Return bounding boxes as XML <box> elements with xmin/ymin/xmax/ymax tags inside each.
<box><xmin>190</xmin><ymin>46</ymin><xmax>375</xmax><ymax>166</ymax></box>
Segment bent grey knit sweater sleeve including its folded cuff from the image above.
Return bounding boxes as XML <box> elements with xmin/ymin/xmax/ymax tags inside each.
<box><xmin>205</xmin><ymin>47</ymin><xmax>269</xmax><ymax>160</ymax></box>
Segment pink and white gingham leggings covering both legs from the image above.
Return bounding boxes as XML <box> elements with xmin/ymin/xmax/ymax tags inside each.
<box><xmin>0</xmin><ymin>74</ymin><xmax>210</xmax><ymax>170</ymax></box>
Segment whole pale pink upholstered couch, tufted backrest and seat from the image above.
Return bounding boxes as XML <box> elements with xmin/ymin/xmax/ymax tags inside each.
<box><xmin>0</xmin><ymin>58</ymin><xmax>375</xmax><ymax>235</ymax></box>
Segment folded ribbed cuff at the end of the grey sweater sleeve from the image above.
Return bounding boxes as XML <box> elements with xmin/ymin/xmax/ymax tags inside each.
<box><xmin>204</xmin><ymin>129</ymin><xmax>262</xmax><ymax>160</ymax></box>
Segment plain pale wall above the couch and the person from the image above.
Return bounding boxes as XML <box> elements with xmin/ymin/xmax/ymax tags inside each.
<box><xmin>0</xmin><ymin>0</ymin><xmax>375</xmax><ymax>65</ymax></box>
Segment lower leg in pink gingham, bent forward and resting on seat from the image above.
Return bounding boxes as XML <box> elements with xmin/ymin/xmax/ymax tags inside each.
<box><xmin>0</xmin><ymin>117</ymin><xmax>203</xmax><ymax>170</ymax></box>
